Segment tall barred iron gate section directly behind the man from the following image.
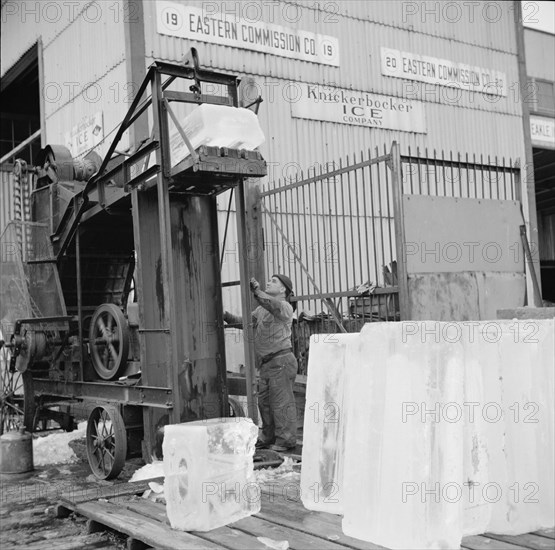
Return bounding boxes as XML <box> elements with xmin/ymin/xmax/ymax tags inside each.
<box><xmin>261</xmin><ymin>142</ymin><xmax>406</xmax><ymax>374</ymax></box>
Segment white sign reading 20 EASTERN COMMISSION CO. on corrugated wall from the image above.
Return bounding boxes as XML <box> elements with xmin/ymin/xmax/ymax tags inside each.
<box><xmin>381</xmin><ymin>48</ymin><xmax>507</xmax><ymax>96</ymax></box>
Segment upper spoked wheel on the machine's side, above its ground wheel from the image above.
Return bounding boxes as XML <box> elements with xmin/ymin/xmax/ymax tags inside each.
<box><xmin>89</xmin><ymin>304</ymin><xmax>129</xmax><ymax>380</ymax></box>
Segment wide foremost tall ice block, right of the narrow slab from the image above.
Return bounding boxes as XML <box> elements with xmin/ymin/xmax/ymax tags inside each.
<box><xmin>343</xmin><ymin>322</ymin><xmax>464</xmax><ymax>550</ymax></box>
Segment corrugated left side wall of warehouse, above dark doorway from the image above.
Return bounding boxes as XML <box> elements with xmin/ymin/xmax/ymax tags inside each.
<box><xmin>1</xmin><ymin>0</ymin><xmax>129</xmax><ymax>162</ymax></box>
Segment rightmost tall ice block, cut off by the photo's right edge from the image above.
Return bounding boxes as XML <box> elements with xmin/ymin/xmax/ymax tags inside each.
<box><xmin>476</xmin><ymin>320</ymin><xmax>555</xmax><ymax>535</ymax></box>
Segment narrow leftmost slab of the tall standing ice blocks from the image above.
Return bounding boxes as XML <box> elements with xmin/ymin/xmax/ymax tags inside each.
<box><xmin>301</xmin><ymin>333</ymin><xmax>359</xmax><ymax>514</ymax></box>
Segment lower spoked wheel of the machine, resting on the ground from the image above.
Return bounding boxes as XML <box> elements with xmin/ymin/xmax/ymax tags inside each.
<box><xmin>87</xmin><ymin>405</ymin><xmax>127</xmax><ymax>479</ymax></box>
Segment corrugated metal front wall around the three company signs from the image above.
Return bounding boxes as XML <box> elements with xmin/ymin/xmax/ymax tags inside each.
<box><xmin>145</xmin><ymin>1</ymin><xmax>523</xmax><ymax>177</ymax></box>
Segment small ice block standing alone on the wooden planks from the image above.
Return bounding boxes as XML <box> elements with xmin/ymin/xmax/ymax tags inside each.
<box><xmin>163</xmin><ymin>418</ymin><xmax>260</xmax><ymax>531</ymax></box>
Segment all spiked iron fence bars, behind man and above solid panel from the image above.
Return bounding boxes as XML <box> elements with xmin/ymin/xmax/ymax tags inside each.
<box><xmin>261</xmin><ymin>144</ymin><xmax>520</xmax><ymax>373</ymax></box>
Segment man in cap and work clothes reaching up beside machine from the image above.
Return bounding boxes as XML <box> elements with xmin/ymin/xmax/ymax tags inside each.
<box><xmin>224</xmin><ymin>275</ymin><xmax>297</xmax><ymax>452</ymax></box>
